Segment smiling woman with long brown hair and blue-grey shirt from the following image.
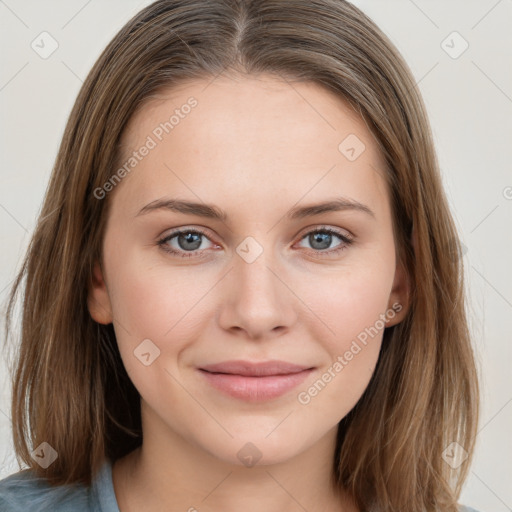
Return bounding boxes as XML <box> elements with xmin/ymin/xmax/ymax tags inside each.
<box><xmin>0</xmin><ymin>0</ymin><xmax>478</xmax><ymax>512</ymax></box>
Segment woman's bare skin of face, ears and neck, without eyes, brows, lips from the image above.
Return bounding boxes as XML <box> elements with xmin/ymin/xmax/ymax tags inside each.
<box><xmin>89</xmin><ymin>75</ymin><xmax>409</xmax><ymax>512</ymax></box>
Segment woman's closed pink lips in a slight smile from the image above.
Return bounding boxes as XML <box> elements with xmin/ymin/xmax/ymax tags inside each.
<box><xmin>199</xmin><ymin>361</ymin><xmax>313</xmax><ymax>402</ymax></box>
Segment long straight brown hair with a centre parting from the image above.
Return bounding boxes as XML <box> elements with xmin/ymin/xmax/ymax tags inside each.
<box><xmin>6</xmin><ymin>0</ymin><xmax>479</xmax><ymax>512</ymax></box>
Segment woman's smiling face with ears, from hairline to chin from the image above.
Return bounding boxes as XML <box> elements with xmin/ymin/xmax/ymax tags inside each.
<box><xmin>89</xmin><ymin>76</ymin><xmax>407</xmax><ymax>464</ymax></box>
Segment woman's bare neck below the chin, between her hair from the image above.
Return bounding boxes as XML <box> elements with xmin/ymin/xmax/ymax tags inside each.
<box><xmin>113</xmin><ymin>402</ymin><xmax>356</xmax><ymax>512</ymax></box>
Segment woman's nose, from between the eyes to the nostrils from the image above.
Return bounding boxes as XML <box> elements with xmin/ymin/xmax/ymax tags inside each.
<box><xmin>219</xmin><ymin>242</ymin><xmax>299</xmax><ymax>339</ymax></box>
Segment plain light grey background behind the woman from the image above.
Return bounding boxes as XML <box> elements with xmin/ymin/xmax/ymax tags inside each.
<box><xmin>0</xmin><ymin>0</ymin><xmax>512</xmax><ymax>512</ymax></box>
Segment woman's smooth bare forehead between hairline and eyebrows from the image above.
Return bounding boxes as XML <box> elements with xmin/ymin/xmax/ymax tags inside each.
<box><xmin>114</xmin><ymin>75</ymin><xmax>390</xmax><ymax>219</ymax></box>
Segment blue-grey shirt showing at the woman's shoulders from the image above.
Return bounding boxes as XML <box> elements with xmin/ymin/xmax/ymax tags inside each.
<box><xmin>0</xmin><ymin>460</ymin><xmax>477</xmax><ymax>512</ymax></box>
